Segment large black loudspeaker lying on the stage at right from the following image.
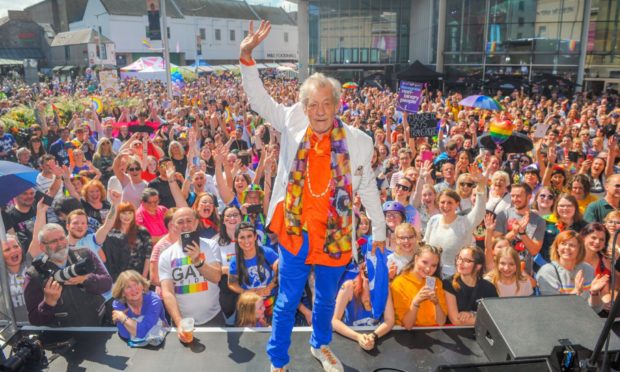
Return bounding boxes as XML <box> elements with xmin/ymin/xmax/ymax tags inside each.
<box><xmin>475</xmin><ymin>295</ymin><xmax>620</xmax><ymax>362</ymax></box>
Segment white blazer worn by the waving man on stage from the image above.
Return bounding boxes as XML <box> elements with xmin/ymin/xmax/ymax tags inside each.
<box><xmin>240</xmin><ymin>64</ymin><xmax>386</xmax><ymax>250</ymax></box>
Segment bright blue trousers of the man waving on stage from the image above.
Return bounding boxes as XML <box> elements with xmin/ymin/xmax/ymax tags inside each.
<box><xmin>267</xmin><ymin>232</ymin><xmax>345</xmax><ymax>368</ymax></box>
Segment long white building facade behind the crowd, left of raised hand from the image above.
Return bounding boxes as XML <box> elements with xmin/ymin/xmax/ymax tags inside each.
<box><xmin>70</xmin><ymin>0</ymin><xmax>299</xmax><ymax>67</ymax></box>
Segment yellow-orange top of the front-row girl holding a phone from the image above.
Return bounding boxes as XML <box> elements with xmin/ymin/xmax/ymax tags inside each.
<box><xmin>390</xmin><ymin>271</ymin><xmax>448</xmax><ymax>327</ymax></box>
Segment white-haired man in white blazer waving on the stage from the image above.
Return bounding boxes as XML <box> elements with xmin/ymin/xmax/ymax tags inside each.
<box><xmin>239</xmin><ymin>21</ymin><xmax>385</xmax><ymax>371</ymax></box>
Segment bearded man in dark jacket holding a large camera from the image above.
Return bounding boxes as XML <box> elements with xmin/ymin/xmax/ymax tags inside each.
<box><xmin>24</xmin><ymin>223</ymin><xmax>112</xmax><ymax>327</ymax></box>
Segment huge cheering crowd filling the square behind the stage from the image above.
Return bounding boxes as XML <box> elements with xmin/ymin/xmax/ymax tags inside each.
<box><xmin>0</xmin><ymin>24</ymin><xmax>620</xmax><ymax>370</ymax></box>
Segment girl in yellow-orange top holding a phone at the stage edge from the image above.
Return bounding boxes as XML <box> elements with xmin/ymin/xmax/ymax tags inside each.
<box><xmin>390</xmin><ymin>244</ymin><xmax>448</xmax><ymax>329</ymax></box>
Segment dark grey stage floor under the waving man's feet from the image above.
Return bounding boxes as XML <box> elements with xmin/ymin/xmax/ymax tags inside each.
<box><xmin>5</xmin><ymin>327</ymin><xmax>488</xmax><ymax>372</ymax></box>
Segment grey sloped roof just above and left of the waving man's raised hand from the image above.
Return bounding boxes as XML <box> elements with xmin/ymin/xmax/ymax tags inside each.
<box><xmin>173</xmin><ymin>0</ymin><xmax>257</xmax><ymax>19</ymax></box>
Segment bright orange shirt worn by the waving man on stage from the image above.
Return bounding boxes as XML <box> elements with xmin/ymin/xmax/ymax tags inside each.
<box><xmin>269</xmin><ymin>127</ymin><xmax>351</xmax><ymax>266</ymax></box>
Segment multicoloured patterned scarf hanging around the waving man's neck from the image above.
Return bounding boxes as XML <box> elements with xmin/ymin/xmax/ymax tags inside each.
<box><xmin>284</xmin><ymin>119</ymin><xmax>353</xmax><ymax>259</ymax></box>
